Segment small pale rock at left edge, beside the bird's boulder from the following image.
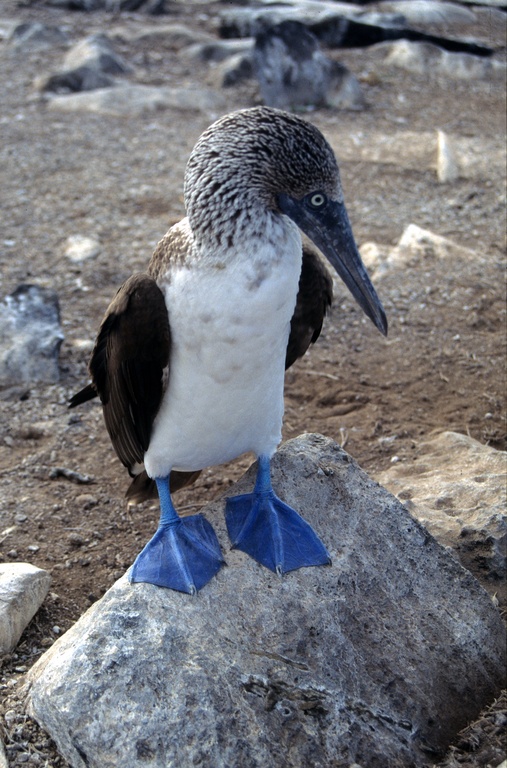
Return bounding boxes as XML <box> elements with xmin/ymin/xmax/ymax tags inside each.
<box><xmin>0</xmin><ymin>563</ymin><xmax>51</xmax><ymax>656</ymax></box>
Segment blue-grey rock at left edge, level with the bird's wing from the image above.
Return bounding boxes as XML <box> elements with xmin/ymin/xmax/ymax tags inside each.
<box><xmin>0</xmin><ymin>285</ymin><xmax>63</xmax><ymax>386</ymax></box>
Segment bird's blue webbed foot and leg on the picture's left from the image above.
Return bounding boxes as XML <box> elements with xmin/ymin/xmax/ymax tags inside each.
<box><xmin>129</xmin><ymin>477</ymin><xmax>224</xmax><ymax>594</ymax></box>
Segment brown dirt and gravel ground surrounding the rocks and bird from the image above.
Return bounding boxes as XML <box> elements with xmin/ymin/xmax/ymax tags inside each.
<box><xmin>0</xmin><ymin>0</ymin><xmax>506</xmax><ymax>766</ymax></box>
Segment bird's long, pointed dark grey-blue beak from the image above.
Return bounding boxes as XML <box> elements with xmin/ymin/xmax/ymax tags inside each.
<box><xmin>278</xmin><ymin>194</ymin><xmax>387</xmax><ymax>336</ymax></box>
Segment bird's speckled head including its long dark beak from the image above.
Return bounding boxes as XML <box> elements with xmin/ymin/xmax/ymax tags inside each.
<box><xmin>185</xmin><ymin>107</ymin><xmax>387</xmax><ymax>335</ymax></box>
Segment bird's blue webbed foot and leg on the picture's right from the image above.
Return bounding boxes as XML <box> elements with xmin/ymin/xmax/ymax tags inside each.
<box><xmin>225</xmin><ymin>456</ymin><xmax>331</xmax><ymax>574</ymax></box>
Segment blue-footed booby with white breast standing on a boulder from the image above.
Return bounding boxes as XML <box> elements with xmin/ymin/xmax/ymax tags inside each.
<box><xmin>70</xmin><ymin>106</ymin><xmax>387</xmax><ymax>594</ymax></box>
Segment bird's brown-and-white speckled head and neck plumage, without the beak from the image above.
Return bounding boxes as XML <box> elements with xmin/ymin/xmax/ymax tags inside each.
<box><xmin>185</xmin><ymin>107</ymin><xmax>342</xmax><ymax>246</ymax></box>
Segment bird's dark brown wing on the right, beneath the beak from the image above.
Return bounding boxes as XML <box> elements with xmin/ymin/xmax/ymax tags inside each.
<box><xmin>285</xmin><ymin>245</ymin><xmax>333</xmax><ymax>370</ymax></box>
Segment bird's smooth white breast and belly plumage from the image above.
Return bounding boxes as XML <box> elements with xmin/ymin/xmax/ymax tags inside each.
<box><xmin>145</xmin><ymin>217</ymin><xmax>301</xmax><ymax>477</ymax></box>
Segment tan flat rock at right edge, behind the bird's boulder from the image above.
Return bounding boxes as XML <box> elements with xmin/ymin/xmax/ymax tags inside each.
<box><xmin>377</xmin><ymin>432</ymin><xmax>507</xmax><ymax>604</ymax></box>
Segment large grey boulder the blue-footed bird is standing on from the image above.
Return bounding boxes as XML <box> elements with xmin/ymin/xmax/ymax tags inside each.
<box><xmin>27</xmin><ymin>435</ymin><xmax>505</xmax><ymax>768</ymax></box>
